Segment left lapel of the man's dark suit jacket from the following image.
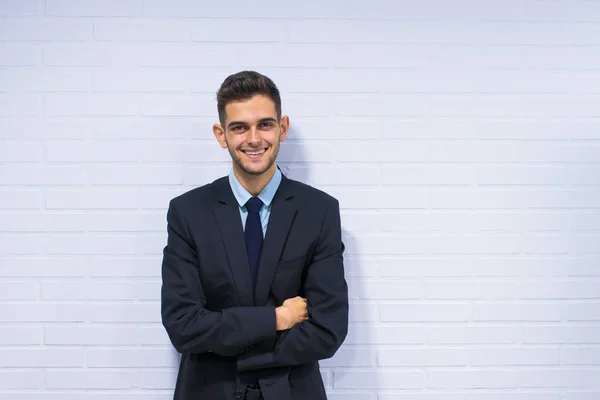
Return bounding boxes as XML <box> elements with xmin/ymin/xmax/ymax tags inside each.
<box><xmin>213</xmin><ymin>178</ymin><xmax>254</xmax><ymax>306</ymax></box>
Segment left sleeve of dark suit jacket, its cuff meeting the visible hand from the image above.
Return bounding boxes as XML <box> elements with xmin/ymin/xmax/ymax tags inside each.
<box><xmin>161</xmin><ymin>200</ymin><xmax>276</xmax><ymax>356</ymax></box>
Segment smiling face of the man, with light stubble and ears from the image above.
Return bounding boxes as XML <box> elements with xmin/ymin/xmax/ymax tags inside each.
<box><xmin>213</xmin><ymin>95</ymin><xmax>289</xmax><ymax>175</ymax></box>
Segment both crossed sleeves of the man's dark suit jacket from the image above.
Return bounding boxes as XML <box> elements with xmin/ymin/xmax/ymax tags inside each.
<box><xmin>161</xmin><ymin>201</ymin><xmax>348</xmax><ymax>371</ymax></box>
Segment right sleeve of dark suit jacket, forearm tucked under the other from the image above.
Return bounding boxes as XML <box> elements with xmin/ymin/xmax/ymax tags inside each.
<box><xmin>237</xmin><ymin>200</ymin><xmax>348</xmax><ymax>371</ymax></box>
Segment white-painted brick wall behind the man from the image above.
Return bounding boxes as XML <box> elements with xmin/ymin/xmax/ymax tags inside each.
<box><xmin>0</xmin><ymin>0</ymin><xmax>600</xmax><ymax>400</ymax></box>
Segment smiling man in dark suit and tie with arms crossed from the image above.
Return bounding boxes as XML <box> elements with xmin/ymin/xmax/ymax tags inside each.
<box><xmin>161</xmin><ymin>71</ymin><xmax>348</xmax><ymax>400</ymax></box>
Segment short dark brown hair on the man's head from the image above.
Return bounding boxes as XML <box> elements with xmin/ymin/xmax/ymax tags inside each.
<box><xmin>217</xmin><ymin>71</ymin><xmax>281</xmax><ymax>125</ymax></box>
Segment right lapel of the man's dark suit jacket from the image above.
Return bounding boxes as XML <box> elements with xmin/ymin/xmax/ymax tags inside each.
<box><xmin>254</xmin><ymin>176</ymin><xmax>296</xmax><ymax>305</ymax></box>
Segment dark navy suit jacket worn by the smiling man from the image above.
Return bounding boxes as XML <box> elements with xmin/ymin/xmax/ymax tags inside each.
<box><xmin>161</xmin><ymin>176</ymin><xmax>348</xmax><ymax>400</ymax></box>
